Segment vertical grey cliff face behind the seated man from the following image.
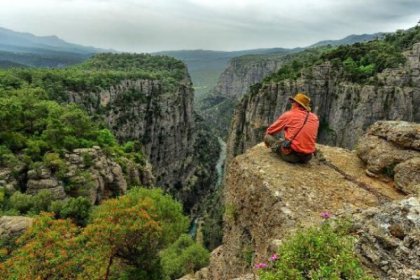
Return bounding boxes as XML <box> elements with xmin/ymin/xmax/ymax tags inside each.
<box><xmin>228</xmin><ymin>43</ymin><xmax>420</xmax><ymax>157</ymax></box>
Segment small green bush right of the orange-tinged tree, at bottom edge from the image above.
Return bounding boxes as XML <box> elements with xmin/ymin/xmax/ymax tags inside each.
<box><xmin>160</xmin><ymin>234</ymin><xmax>210</xmax><ymax>280</ymax></box>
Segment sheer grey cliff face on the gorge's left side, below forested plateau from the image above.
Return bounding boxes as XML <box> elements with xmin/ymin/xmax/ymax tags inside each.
<box><xmin>68</xmin><ymin>77</ymin><xmax>219</xmax><ymax>212</ymax></box>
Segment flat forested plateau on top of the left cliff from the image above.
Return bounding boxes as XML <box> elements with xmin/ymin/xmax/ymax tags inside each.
<box><xmin>0</xmin><ymin>53</ymin><xmax>186</xmax><ymax>102</ymax></box>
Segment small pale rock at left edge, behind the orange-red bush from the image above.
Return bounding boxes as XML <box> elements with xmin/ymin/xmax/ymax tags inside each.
<box><xmin>0</xmin><ymin>216</ymin><xmax>32</xmax><ymax>240</ymax></box>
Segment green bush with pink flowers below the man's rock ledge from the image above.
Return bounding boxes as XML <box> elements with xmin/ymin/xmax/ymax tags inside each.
<box><xmin>257</xmin><ymin>221</ymin><xmax>371</xmax><ymax>280</ymax></box>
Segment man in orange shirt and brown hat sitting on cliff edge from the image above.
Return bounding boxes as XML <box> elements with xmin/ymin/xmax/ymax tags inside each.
<box><xmin>264</xmin><ymin>93</ymin><xmax>319</xmax><ymax>163</ymax></box>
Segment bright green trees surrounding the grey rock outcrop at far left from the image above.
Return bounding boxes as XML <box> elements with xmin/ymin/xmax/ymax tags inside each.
<box><xmin>0</xmin><ymin>85</ymin><xmax>144</xmax><ymax>219</ymax></box>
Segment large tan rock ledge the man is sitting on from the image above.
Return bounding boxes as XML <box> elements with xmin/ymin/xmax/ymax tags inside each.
<box><xmin>208</xmin><ymin>144</ymin><xmax>403</xmax><ymax>279</ymax></box>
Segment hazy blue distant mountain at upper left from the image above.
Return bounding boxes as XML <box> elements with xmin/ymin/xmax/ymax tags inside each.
<box><xmin>0</xmin><ymin>27</ymin><xmax>111</xmax><ymax>68</ymax></box>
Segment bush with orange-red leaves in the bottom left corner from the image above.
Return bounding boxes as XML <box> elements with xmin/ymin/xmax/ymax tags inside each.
<box><xmin>0</xmin><ymin>213</ymin><xmax>80</xmax><ymax>280</ymax></box>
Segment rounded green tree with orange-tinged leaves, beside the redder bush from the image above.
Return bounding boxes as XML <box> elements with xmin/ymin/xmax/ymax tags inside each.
<box><xmin>78</xmin><ymin>188</ymin><xmax>188</xmax><ymax>279</ymax></box>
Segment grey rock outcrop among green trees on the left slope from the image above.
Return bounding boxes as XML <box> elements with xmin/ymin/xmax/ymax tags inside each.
<box><xmin>0</xmin><ymin>147</ymin><xmax>154</xmax><ymax>204</ymax></box>
